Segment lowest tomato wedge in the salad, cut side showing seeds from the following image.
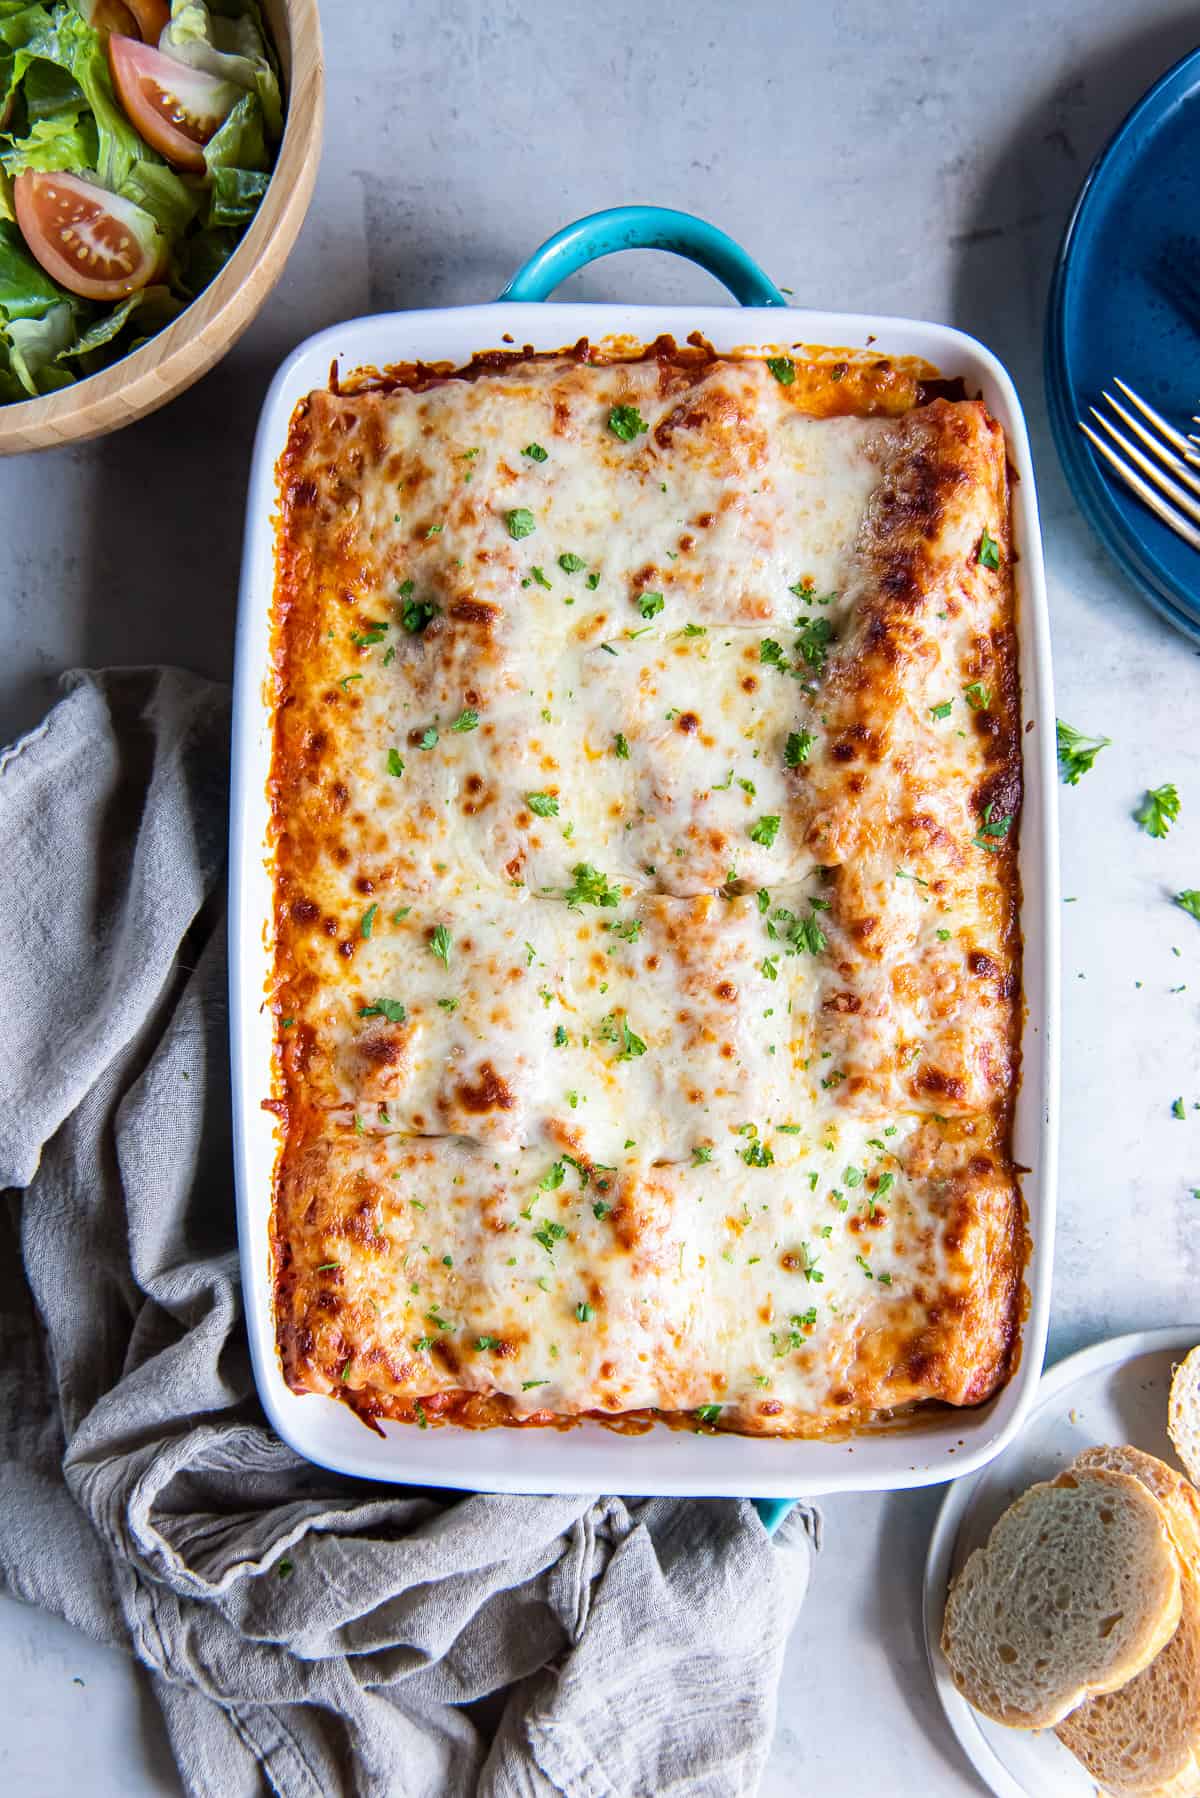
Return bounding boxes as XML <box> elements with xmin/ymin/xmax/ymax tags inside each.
<box><xmin>13</xmin><ymin>169</ymin><xmax>167</xmax><ymax>300</ymax></box>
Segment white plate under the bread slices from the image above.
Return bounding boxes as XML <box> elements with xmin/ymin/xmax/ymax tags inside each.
<box><xmin>925</xmin><ymin>1323</ymin><xmax>1200</xmax><ymax>1798</ymax></box>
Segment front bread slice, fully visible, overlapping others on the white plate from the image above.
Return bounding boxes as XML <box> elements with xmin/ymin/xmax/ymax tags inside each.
<box><xmin>941</xmin><ymin>1467</ymin><xmax>1180</xmax><ymax>1730</ymax></box>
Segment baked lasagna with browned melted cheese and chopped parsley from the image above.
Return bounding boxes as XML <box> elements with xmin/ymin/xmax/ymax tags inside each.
<box><xmin>268</xmin><ymin>340</ymin><xmax>1025</xmax><ymax>1437</ymax></box>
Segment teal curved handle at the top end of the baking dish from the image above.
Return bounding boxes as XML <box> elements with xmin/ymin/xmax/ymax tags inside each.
<box><xmin>500</xmin><ymin>207</ymin><xmax>788</xmax><ymax>306</ymax></box>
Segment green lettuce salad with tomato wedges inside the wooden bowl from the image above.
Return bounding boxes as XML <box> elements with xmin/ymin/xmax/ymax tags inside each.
<box><xmin>0</xmin><ymin>0</ymin><xmax>282</xmax><ymax>403</ymax></box>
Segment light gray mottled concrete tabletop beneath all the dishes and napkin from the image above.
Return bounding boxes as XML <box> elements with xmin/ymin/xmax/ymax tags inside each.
<box><xmin>0</xmin><ymin>0</ymin><xmax>1200</xmax><ymax>1798</ymax></box>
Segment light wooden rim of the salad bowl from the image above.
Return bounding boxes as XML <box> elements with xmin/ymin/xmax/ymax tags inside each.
<box><xmin>0</xmin><ymin>0</ymin><xmax>326</xmax><ymax>455</ymax></box>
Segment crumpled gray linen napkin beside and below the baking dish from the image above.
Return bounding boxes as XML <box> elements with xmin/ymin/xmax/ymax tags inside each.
<box><xmin>0</xmin><ymin>669</ymin><xmax>815</xmax><ymax>1798</ymax></box>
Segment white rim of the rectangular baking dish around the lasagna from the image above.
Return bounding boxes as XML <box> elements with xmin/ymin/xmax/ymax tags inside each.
<box><xmin>228</xmin><ymin>210</ymin><xmax>1058</xmax><ymax>1498</ymax></box>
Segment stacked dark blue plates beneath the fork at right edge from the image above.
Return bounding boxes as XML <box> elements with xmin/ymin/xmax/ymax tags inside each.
<box><xmin>1045</xmin><ymin>40</ymin><xmax>1200</xmax><ymax>644</ymax></box>
